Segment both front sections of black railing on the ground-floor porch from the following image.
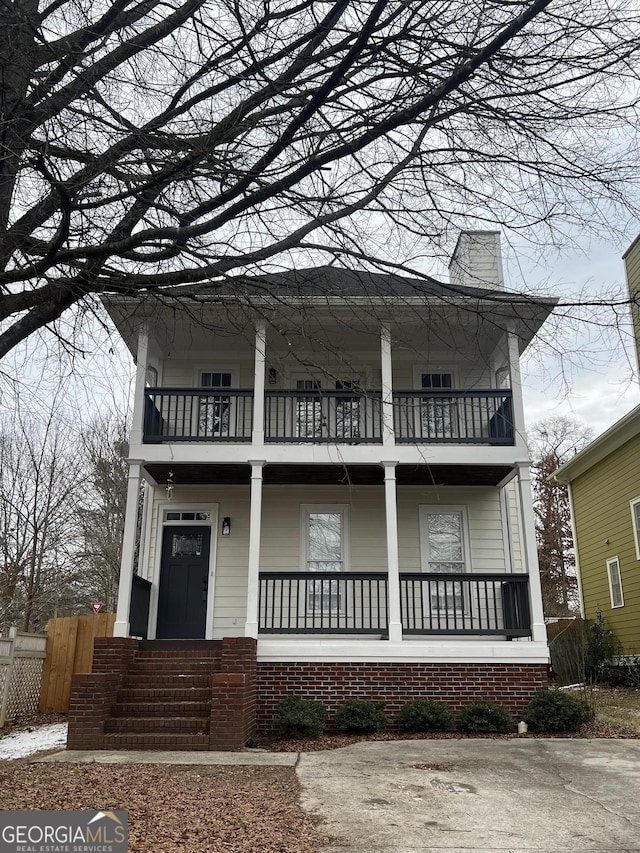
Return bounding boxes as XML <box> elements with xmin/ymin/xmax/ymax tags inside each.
<box><xmin>259</xmin><ymin>572</ymin><xmax>531</xmax><ymax>638</ymax></box>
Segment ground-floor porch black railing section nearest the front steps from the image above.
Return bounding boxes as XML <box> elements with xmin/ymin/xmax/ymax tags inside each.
<box><xmin>258</xmin><ymin>572</ymin><xmax>387</xmax><ymax>634</ymax></box>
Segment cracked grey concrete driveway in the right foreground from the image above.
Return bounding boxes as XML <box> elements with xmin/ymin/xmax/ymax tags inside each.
<box><xmin>297</xmin><ymin>739</ymin><xmax>640</xmax><ymax>853</ymax></box>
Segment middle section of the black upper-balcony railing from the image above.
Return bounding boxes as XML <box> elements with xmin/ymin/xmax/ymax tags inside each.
<box><xmin>265</xmin><ymin>389</ymin><xmax>382</xmax><ymax>444</ymax></box>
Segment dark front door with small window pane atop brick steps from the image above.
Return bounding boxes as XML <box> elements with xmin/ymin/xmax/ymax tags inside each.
<box><xmin>156</xmin><ymin>525</ymin><xmax>211</xmax><ymax>639</ymax></box>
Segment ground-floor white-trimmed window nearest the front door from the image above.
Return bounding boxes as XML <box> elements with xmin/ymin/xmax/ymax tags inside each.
<box><xmin>302</xmin><ymin>505</ymin><xmax>347</xmax><ymax>612</ymax></box>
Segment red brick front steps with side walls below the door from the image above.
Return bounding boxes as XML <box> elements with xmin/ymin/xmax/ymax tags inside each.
<box><xmin>67</xmin><ymin>638</ymin><xmax>256</xmax><ymax>750</ymax></box>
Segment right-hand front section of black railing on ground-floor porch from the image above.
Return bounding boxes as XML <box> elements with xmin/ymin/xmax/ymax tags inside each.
<box><xmin>400</xmin><ymin>574</ymin><xmax>531</xmax><ymax>637</ymax></box>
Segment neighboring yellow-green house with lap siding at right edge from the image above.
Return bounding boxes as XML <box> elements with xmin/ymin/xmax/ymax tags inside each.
<box><xmin>554</xmin><ymin>406</ymin><xmax>640</xmax><ymax>654</ymax></box>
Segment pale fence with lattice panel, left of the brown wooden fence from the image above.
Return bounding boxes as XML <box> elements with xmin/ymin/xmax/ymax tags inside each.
<box><xmin>0</xmin><ymin>628</ymin><xmax>47</xmax><ymax>728</ymax></box>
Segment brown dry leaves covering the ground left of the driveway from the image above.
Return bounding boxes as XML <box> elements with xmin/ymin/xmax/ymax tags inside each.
<box><xmin>0</xmin><ymin>761</ymin><xmax>327</xmax><ymax>853</ymax></box>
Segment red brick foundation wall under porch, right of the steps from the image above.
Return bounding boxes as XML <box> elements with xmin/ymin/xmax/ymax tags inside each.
<box><xmin>257</xmin><ymin>663</ymin><xmax>548</xmax><ymax>732</ymax></box>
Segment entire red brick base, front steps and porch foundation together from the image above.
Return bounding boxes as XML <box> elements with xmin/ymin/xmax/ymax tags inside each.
<box><xmin>67</xmin><ymin>637</ymin><xmax>548</xmax><ymax>750</ymax></box>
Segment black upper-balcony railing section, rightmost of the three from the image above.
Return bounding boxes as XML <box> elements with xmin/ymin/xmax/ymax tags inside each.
<box><xmin>393</xmin><ymin>389</ymin><xmax>514</xmax><ymax>444</ymax></box>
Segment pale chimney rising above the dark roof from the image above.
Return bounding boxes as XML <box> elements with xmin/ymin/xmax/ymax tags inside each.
<box><xmin>449</xmin><ymin>231</ymin><xmax>504</xmax><ymax>290</ymax></box>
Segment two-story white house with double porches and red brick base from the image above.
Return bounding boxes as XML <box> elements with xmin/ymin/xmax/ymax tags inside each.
<box><xmin>69</xmin><ymin>232</ymin><xmax>554</xmax><ymax>749</ymax></box>
